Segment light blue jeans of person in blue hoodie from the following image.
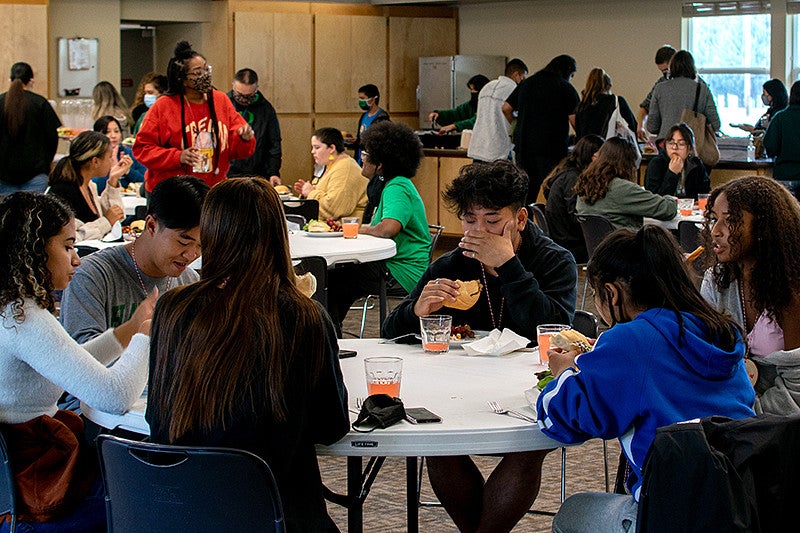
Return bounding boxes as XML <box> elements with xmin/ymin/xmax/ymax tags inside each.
<box><xmin>553</xmin><ymin>492</ymin><xmax>639</xmax><ymax>533</ymax></box>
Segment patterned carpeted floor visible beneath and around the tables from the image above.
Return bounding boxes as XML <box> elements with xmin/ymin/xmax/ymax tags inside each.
<box><xmin>319</xmin><ymin>262</ymin><xmax>619</xmax><ymax>533</ymax></box>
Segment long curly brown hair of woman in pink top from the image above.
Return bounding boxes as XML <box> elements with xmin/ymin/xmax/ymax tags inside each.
<box><xmin>702</xmin><ymin>176</ymin><xmax>800</xmax><ymax>321</ymax></box>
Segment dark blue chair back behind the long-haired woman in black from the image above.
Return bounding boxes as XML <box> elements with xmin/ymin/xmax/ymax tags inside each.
<box><xmin>97</xmin><ymin>435</ymin><xmax>286</xmax><ymax>533</ymax></box>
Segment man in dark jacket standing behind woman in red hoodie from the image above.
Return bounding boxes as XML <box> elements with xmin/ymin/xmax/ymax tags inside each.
<box><xmin>228</xmin><ymin>68</ymin><xmax>281</xmax><ymax>185</ymax></box>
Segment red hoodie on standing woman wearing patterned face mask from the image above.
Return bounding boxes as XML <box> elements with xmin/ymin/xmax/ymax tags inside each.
<box><xmin>133</xmin><ymin>89</ymin><xmax>256</xmax><ymax>192</ymax></box>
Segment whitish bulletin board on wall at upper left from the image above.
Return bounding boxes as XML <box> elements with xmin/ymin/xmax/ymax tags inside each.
<box><xmin>58</xmin><ymin>37</ymin><xmax>98</xmax><ymax>98</ymax></box>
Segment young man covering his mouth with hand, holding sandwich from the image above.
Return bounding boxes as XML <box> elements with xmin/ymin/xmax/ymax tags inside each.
<box><xmin>382</xmin><ymin>160</ymin><xmax>577</xmax><ymax>531</ymax></box>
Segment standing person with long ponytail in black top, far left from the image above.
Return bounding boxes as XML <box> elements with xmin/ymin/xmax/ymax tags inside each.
<box><xmin>0</xmin><ymin>62</ymin><xmax>61</xmax><ymax>197</ymax></box>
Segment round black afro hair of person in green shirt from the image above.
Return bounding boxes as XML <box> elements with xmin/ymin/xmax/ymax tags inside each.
<box><xmin>361</xmin><ymin>120</ymin><xmax>422</xmax><ymax>181</ymax></box>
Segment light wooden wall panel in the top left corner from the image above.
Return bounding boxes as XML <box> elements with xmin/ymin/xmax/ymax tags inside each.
<box><xmin>0</xmin><ymin>3</ymin><xmax>50</xmax><ymax>97</ymax></box>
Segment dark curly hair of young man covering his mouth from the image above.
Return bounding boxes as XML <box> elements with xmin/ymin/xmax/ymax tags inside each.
<box><xmin>442</xmin><ymin>160</ymin><xmax>528</xmax><ymax>218</ymax></box>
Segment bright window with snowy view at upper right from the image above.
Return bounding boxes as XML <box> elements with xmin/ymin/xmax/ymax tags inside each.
<box><xmin>683</xmin><ymin>1</ymin><xmax>771</xmax><ymax>137</ymax></box>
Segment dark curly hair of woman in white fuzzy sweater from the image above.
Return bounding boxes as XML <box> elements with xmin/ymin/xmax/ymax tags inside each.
<box><xmin>0</xmin><ymin>192</ymin><xmax>73</xmax><ymax>324</ymax></box>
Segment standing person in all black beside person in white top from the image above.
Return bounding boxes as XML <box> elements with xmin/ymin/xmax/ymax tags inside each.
<box><xmin>503</xmin><ymin>55</ymin><xmax>579</xmax><ymax>204</ymax></box>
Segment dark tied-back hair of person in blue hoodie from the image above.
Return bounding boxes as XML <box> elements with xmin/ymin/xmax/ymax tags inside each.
<box><xmin>587</xmin><ymin>225</ymin><xmax>740</xmax><ymax>351</ymax></box>
